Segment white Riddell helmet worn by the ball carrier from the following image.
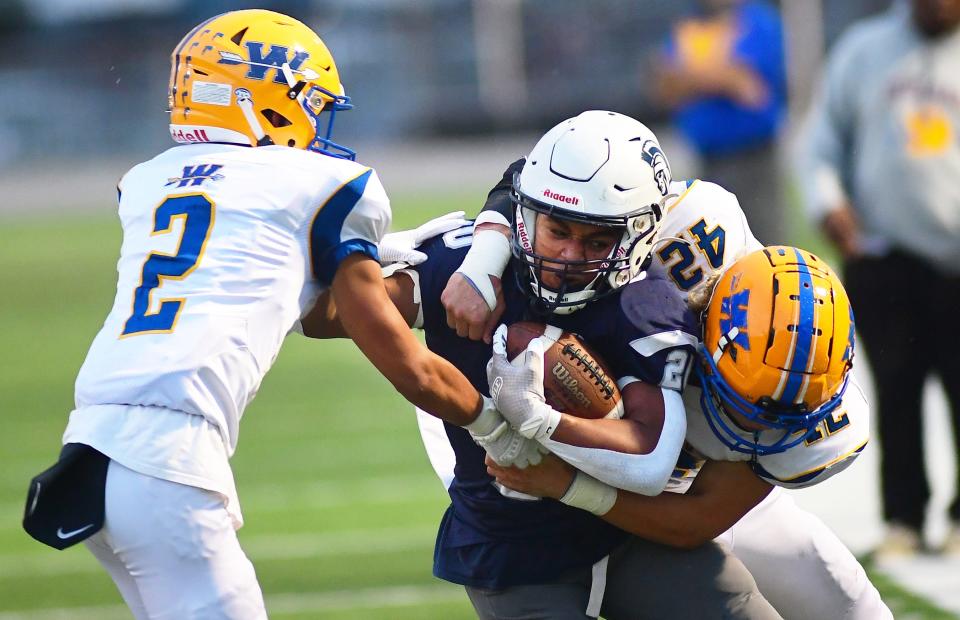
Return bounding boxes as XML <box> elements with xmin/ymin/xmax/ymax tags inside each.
<box><xmin>513</xmin><ymin>110</ymin><xmax>671</xmax><ymax>314</ymax></box>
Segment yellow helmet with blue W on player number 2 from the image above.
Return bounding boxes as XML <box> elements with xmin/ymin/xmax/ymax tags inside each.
<box><xmin>168</xmin><ymin>9</ymin><xmax>356</xmax><ymax>159</ymax></box>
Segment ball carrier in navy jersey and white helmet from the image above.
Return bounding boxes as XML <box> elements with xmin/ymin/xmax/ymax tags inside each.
<box><xmin>303</xmin><ymin>112</ymin><xmax>779</xmax><ymax>619</ymax></box>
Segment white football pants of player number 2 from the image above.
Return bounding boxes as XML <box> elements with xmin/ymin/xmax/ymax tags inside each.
<box><xmin>86</xmin><ymin>461</ymin><xmax>267</xmax><ymax>620</ymax></box>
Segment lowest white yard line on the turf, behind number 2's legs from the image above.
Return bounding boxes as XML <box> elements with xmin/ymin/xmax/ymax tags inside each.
<box><xmin>0</xmin><ymin>584</ymin><xmax>467</xmax><ymax>620</ymax></box>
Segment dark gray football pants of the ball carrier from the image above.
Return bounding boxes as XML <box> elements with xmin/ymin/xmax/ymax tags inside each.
<box><xmin>467</xmin><ymin>537</ymin><xmax>780</xmax><ymax>620</ymax></box>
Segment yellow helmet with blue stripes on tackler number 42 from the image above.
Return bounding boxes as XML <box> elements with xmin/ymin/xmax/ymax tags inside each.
<box><xmin>697</xmin><ymin>246</ymin><xmax>854</xmax><ymax>455</ymax></box>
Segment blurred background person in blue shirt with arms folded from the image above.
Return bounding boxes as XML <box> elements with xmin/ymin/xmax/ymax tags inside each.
<box><xmin>654</xmin><ymin>0</ymin><xmax>787</xmax><ymax>244</ymax></box>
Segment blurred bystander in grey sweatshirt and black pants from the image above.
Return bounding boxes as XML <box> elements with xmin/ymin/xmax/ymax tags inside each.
<box><xmin>801</xmin><ymin>0</ymin><xmax>960</xmax><ymax>557</ymax></box>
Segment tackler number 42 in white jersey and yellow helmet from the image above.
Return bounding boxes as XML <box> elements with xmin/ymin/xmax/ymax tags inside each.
<box><xmin>436</xmin><ymin>114</ymin><xmax>891</xmax><ymax>620</ymax></box>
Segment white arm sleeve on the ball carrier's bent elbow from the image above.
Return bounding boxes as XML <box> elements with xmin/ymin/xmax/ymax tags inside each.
<box><xmin>541</xmin><ymin>388</ymin><xmax>687</xmax><ymax>495</ymax></box>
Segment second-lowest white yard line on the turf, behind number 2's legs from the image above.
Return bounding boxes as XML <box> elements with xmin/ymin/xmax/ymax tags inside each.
<box><xmin>0</xmin><ymin>526</ymin><xmax>437</xmax><ymax>579</ymax></box>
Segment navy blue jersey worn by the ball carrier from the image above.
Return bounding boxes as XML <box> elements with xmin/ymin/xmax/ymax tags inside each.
<box><xmin>414</xmin><ymin>226</ymin><xmax>698</xmax><ymax>588</ymax></box>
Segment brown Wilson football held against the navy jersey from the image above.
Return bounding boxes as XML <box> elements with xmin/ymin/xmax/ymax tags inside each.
<box><xmin>507</xmin><ymin>321</ymin><xmax>623</xmax><ymax>419</ymax></box>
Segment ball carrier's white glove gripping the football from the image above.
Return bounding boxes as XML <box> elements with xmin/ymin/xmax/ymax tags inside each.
<box><xmin>487</xmin><ymin>325</ymin><xmax>561</xmax><ymax>441</ymax></box>
